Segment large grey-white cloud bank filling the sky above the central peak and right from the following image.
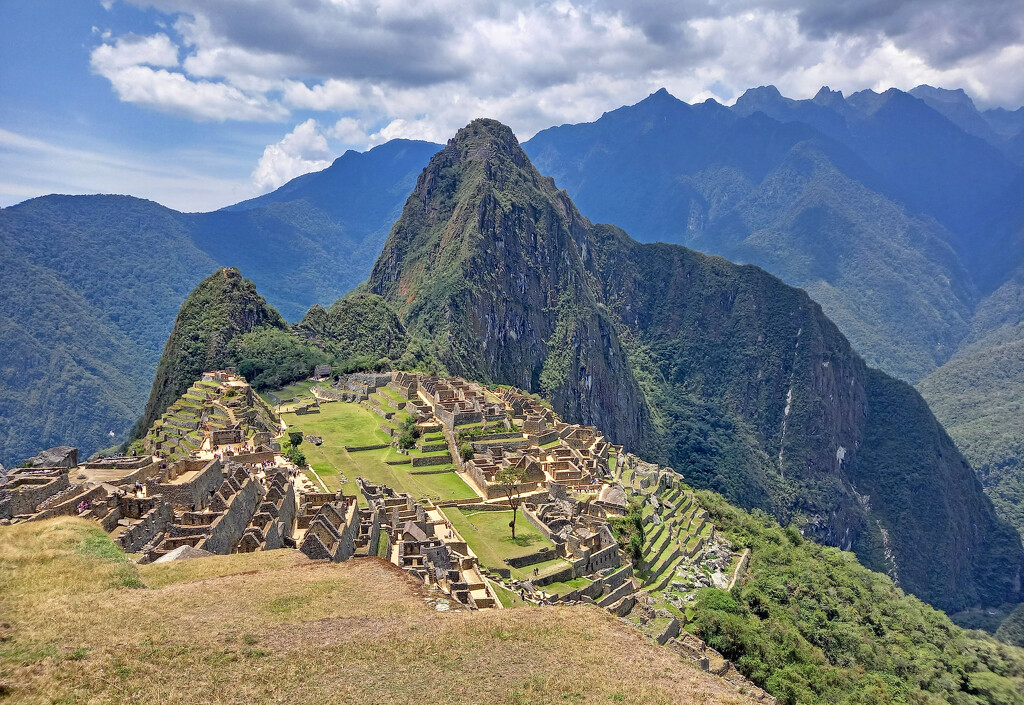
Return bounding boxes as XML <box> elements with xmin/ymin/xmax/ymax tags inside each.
<box><xmin>61</xmin><ymin>0</ymin><xmax>1024</xmax><ymax>209</ymax></box>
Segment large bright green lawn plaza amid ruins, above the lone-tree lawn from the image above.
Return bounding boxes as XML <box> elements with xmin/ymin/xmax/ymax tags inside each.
<box><xmin>282</xmin><ymin>402</ymin><xmax>476</xmax><ymax>503</ymax></box>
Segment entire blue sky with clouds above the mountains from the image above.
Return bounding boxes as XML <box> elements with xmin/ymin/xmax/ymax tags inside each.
<box><xmin>0</xmin><ymin>0</ymin><xmax>1024</xmax><ymax>211</ymax></box>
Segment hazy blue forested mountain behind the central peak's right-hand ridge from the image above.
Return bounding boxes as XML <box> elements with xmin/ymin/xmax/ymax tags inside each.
<box><xmin>523</xmin><ymin>88</ymin><xmax>977</xmax><ymax>381</ymax></box>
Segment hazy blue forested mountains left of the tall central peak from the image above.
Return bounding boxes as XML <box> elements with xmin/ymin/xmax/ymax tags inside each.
<box><xmin>0</xmin><ymin>139</ymin><xmax>437</xmax><ymax>465</ymax></box>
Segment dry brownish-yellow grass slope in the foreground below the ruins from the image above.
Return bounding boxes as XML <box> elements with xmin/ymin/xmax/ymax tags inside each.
<box><xmin>0</xmin><ymin>519</ymin><xmax>746</xmax><ymax>705</ymax></box>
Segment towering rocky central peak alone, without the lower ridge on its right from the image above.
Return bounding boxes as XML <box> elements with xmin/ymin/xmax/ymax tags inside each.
<box><xmin>369</xmin><ymin>120</ymin><xmax>650</xmax><ymax>448</ymax></box>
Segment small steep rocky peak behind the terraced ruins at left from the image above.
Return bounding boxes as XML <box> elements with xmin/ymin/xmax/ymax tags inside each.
<box><xmin>139</xmin><ymin>267</ymin><xmax>288</xmax><ymax>432</ymax></box>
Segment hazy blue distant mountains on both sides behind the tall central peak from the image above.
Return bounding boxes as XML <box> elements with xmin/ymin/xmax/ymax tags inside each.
<box><xmin>0</xmin><ymin>87</ymin><xmax>1024</xmax><ymax>545</ymax></box>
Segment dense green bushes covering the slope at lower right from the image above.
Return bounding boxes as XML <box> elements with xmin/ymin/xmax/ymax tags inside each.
<box><xmin>700</xmin><ymin>492</ymin><xmax>1024</xmax><ymax>704</ymax></box>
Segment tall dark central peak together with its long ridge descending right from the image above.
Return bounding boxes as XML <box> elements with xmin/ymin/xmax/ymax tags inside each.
<box><xmin>365</xmin><ymin>120</ymin><xmax>1022</xmax><ymax>609</ymax></box>
